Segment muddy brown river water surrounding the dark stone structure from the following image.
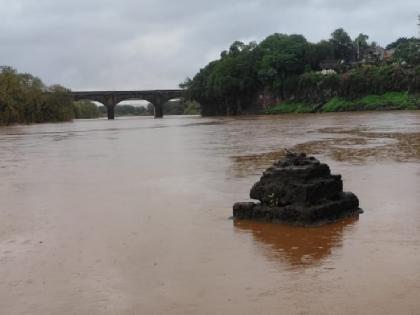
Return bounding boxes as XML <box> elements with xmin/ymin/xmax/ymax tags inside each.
<box><xmin>0</xmin><ymin>112</ymin><xmax>420</xmax><ymax>315</ymax></box>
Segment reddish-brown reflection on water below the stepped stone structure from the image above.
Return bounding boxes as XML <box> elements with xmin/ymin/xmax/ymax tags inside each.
<box><xmin>233</xmin><ymin>218</ymin><xmax>358</xmax><ymax>267</ymax></box>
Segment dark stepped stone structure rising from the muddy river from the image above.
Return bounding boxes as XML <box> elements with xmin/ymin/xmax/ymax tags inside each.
<box><xmin>233</xmin><ymin>152</ymin><xmax>363</xmax><ymax>225</ymax></box>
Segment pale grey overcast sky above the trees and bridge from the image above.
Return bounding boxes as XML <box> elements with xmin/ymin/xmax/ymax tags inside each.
<box><xmin>0</xmin><ymin>0</ymin><xmax>420</xmax><ymax>90</ymax></box>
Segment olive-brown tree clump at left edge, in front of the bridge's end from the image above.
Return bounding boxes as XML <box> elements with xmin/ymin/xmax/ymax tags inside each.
<box><xmin>0</xmin><ymin>67</ymin><xmax>74</xmax><ymax>125</ymax></box>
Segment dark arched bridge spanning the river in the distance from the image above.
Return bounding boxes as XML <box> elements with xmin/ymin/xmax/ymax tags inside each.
<box><xmin>71</xmin><ymin>90</ymin><xmax>184</xmax><ymax>119</ymax></box>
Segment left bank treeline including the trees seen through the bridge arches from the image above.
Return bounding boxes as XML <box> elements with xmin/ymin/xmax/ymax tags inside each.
<box><xmin>0</xmin><ymin>66</ymin><xmax>200</xmax><ymax>125</ymax></box>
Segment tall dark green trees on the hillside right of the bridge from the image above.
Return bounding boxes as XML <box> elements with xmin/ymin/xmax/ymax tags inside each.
<box><xmin>181</xmin><ymin>28</ymin><xmax>420</xmax><ymax>115</ymax></box>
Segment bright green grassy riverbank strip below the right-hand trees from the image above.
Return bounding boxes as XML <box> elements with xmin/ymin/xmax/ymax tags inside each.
<box><xmin>264</xmin><ymin>92</ymin><xmax>420</xmax><ymax>115</ymax></box>
